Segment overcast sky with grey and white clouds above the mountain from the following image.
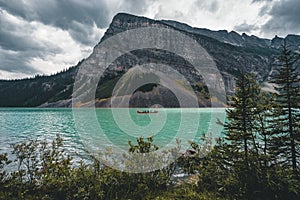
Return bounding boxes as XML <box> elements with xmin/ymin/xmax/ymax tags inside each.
<box><xmin>0</xmin><ymin>0</ymin><xmax>300</xmax><ymax>79</ymax></box>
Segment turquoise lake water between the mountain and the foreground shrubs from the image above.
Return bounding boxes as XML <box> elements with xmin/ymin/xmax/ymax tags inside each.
<box><xmin>0</xmin><ymin>108</ymin><xmax>225</xmax><ymax>162</ymax></box>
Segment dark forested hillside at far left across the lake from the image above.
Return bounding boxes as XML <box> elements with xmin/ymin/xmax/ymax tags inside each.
<box><xmin>0</xmin><ymin>66</ymin><xmax>77</xmax><ymax>107</ymax></box>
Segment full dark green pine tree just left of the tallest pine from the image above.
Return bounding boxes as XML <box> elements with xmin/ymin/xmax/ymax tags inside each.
<box><xmin>222</xmin><ymin>73</ymin><xmax>262</xmax><ymax>199</ymax></box>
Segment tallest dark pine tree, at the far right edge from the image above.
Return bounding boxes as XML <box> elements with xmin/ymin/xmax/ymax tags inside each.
<box><xmin>272</xmin><ymin>41</ymin><xmax>300</xmax><ymax>173</ymax></box>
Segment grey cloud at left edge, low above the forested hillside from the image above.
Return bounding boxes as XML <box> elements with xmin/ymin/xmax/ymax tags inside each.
<box><xmin>0</xmin><ymin>10</ymin><xmax>62</xmax><ymax>74</ymax></box>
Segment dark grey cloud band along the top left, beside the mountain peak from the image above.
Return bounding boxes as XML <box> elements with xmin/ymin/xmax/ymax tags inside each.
<box><xmin>0</xmin><ymin>0</ymin><xmax>109</xmax><ymax>45</ymax></box>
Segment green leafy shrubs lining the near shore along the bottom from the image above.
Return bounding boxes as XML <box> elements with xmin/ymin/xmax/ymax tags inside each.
<box><xmin>0</xmin><ymin>132</ymin><xmax>300</xmax><ymax>199</ymax></box>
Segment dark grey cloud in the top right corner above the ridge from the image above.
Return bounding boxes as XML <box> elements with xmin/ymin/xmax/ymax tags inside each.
<box><xmin>262</xmin><ymin>0</ymin><xmax>300</xmax><ymax>36</ymax></box>
